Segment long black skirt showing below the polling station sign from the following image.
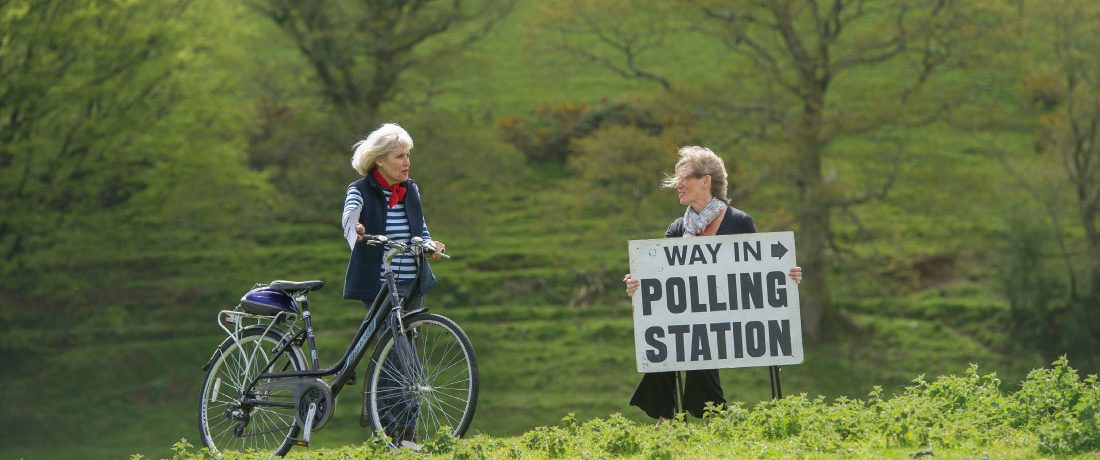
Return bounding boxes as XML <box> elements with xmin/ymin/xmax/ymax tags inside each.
<box><xmin>630</xmin><ymin>369</ymin><xmax>726</xmax><ymax>418</ymax></box>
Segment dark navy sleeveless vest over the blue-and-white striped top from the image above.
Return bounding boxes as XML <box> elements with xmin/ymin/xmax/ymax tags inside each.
<box><xmin>344</xmin><ymin>175</ymin><xmax>436</xmax><ymax>302</ymax></box>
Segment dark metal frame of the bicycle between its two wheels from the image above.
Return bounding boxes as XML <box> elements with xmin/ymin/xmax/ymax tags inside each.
<box><xmin>242</xmin><ymin>255</ymin><xmax>424</xmax><ymax>406</ymax></box>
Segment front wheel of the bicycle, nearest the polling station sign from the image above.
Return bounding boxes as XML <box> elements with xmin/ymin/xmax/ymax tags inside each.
<box><xmin>366</xmin><ymin>314</ymin><xmax>477</xmax><ymax>445</ymax></box>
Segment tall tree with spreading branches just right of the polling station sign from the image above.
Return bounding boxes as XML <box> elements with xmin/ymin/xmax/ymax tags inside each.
<box><xmin>530</xmin><ymin>0</ymin><xmax>997</xmax><ymax>339</ymax></box>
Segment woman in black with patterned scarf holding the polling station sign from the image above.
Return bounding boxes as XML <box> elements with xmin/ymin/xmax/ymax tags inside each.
<box><xmin>623</xmin><ymin>146</ymin><xmax>802</xmax><ymax>425</ymax></box>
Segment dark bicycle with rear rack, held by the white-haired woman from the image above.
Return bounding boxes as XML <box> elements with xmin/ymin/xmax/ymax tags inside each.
<box><xmin>199</xmin><ymin>236</ymin><xmax>477</xmax><ymax>457</ymax></box>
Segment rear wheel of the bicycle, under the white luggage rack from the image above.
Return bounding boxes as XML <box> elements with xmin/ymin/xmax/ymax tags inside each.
<box><xmin>199</xmin><ymin>327</ymin><xmax>306</xmax><ymax>457</ymax></box>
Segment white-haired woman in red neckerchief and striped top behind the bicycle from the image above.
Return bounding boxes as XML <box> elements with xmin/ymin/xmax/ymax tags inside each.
<box><xmin>342</xmin><ymin>123</ymin><xmax>446</xmax><ymax>442</ymax></box>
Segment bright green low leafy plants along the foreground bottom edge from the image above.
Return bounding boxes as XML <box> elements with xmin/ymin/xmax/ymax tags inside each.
<box><xmin>159</xmin><ymin>359</ymin><xmax>1100</xmax><ymax>459</ymax></box>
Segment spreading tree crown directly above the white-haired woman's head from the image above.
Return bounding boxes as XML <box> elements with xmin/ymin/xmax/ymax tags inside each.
<box><xmin>250</xmin><ymin>0</ymin><xmax>515</xmax><ymax>125</ymax></box>
